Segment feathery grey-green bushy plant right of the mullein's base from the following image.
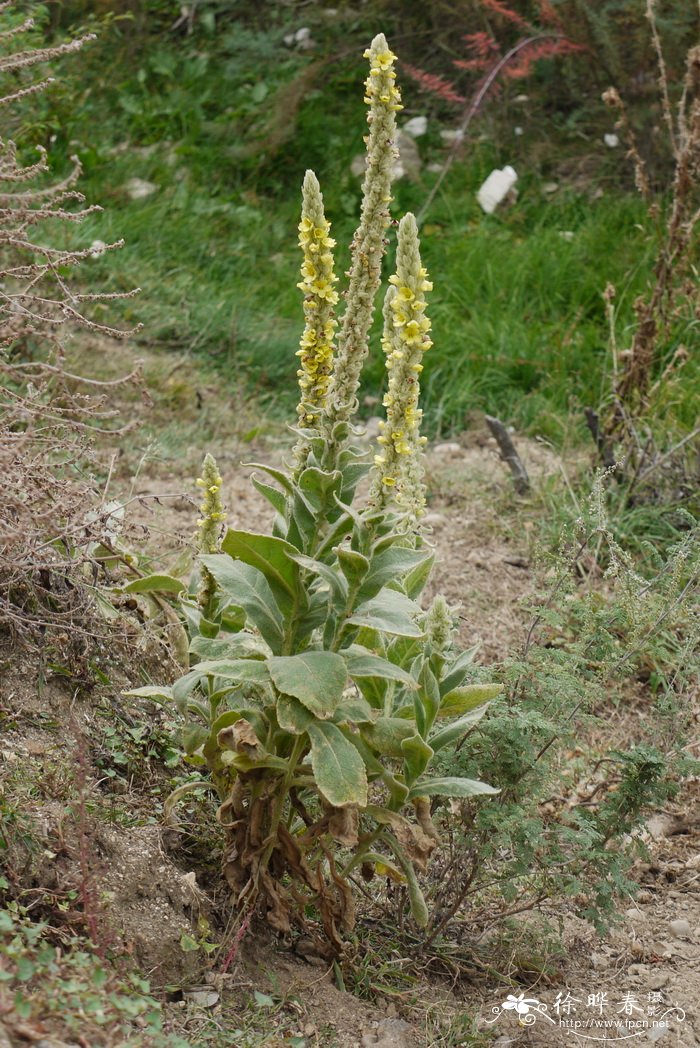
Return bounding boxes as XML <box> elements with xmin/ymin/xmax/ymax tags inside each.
<box><xmin>426</xmin><ymin>475</ymin><xmax>700</xmax><ymax>940</ymax></box>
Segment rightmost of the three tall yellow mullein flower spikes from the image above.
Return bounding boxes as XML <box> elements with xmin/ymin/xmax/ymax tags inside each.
<box><xmin>369</xmin><ymin>214</ymin><xmax>433</xmax><ymax>527</ymax></box>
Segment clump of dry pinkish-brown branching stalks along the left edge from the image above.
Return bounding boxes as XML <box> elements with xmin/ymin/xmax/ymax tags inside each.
<box><xmin>0</xmin><ymin>2</ymin><xmax>137</xmax><ymax>637</ymax></box>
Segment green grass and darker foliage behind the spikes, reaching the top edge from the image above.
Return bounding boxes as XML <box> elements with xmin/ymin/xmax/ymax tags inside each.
<box><xmin>19</xmin><ymin>0</ymin><xmax>698</xmax><ymax>440</ymax></box>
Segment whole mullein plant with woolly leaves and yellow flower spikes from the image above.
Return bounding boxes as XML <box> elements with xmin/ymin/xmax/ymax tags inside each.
<box><xmin>130</xmin><ymin>36</ymin><xmax>500</xmax><ymax>955</ymax></box>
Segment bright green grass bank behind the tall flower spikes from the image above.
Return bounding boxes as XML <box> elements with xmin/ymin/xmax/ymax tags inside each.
<box><xmin>36</xmin><ymin>7</ymin><xmax>698</xmax><ymax>440</ymax></box>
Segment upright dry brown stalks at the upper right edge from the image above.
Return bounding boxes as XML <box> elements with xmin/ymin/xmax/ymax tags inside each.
<box><xmin>586</xmin><ymin>0</ymin><xmax>700</xmax><ymax>497</ymax></box>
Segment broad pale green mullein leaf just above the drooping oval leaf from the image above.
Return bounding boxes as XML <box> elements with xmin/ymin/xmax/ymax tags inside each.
<box><xmin>267</xmin><ymin>652</ymin><xmax>348</xmax><ymax>718</ymax></box>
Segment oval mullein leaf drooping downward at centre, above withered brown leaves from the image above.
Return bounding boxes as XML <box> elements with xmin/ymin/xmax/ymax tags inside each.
<box><xmin>308</xmin><ymin>721</ymin><xmax>367</xmax><ymax>808</ymax></box>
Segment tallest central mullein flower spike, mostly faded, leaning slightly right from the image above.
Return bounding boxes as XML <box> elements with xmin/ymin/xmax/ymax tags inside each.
<box><xmin>328</xmin><ymin>34</ymin><xmax>403</xmax><ymax>424</ymax></box>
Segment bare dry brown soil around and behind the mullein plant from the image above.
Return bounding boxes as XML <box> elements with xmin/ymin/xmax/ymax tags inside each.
<box><xmin>0</xmin><ymin>341</ymin><xmax>700</xmax><ymax>1048</ymax></box>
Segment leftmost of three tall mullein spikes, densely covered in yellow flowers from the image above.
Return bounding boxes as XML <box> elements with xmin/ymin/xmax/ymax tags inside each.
<box><xmin>297</xmin><ymin>171</ymin><xmax>337</xmax><ymax>433</ymax></box>
